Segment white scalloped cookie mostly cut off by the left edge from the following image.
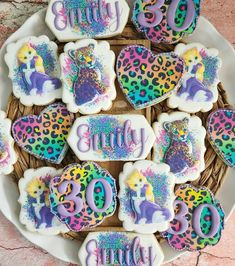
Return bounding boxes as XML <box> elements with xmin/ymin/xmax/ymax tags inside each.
<box><xmin>0</xmin><ymin>111</ymin><xmax>17</xmax><ymax>175</ymax></box>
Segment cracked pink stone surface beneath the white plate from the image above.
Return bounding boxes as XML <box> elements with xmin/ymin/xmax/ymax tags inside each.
<box><xmin>0</xmin><ymin>0</ymin><xmax>235</xmax><ymax>266</ymax></box>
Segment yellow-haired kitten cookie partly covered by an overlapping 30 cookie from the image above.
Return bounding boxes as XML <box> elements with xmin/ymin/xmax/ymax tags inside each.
<box><xmin>19</xmin><ymin>167</ymin><xmax>69</xmax><ymax>235</ymax></box>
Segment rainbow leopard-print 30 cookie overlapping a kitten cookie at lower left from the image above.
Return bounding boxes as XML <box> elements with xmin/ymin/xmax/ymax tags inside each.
<box><xmin>50</xmin><ymin>162</ymin><xmax>117</xmax><ymax>232</ymax></box>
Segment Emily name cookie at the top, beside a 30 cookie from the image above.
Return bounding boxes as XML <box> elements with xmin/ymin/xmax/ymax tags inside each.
<box><xmin>46</xmin><ymin>0</ymin><xmax>129</xmax><ymax>42</ymax></box>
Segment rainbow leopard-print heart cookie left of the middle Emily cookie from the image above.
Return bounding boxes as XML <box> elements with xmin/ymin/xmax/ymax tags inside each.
<box><xmin>12</xmin><ymin>103</ymin><xmax>73</xmax><ymax>164</ymax></box>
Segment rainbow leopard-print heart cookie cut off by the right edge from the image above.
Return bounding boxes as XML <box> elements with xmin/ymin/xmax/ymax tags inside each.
<box><xmin>207</xmin><ymin>109</ymin><xmax>235</xmax><ymax>168</ymax></box>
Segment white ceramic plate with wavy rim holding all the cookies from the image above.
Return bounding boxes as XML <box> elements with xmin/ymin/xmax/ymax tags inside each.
<box><xmin>0</xmin><ymin>7</ymin><xmax>235</xmax><ymax>264</ymax></box>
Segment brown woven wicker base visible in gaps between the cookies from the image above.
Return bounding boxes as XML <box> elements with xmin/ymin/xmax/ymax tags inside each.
<box><xmin>7</xmin><ymin>24</ymin><xmax>230</xmax><ymax>241</ymax></box>
